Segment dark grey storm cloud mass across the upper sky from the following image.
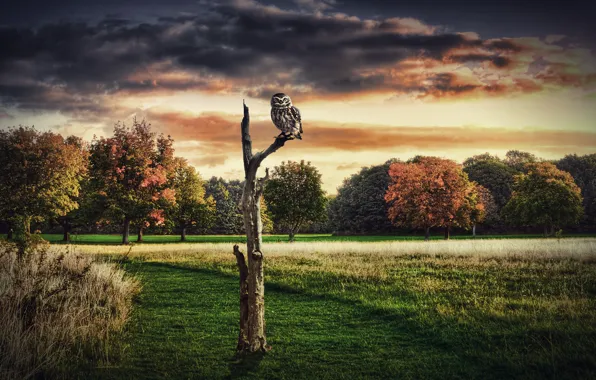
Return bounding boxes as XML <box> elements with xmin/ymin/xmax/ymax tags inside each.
<box><xmin>0</xmin><ymin>0</ymin><xmax>588</xmax><ymax>119</ymax></box>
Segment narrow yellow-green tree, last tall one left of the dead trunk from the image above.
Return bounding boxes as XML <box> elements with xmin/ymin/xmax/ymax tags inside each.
<box><xmin>166</xmin><ymin>159</ymin><xmax>215</xmax><ymax>241</ymax></box>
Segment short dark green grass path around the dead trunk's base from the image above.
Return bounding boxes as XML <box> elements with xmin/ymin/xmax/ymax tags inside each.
<box><xmin>84</xmin><ymin>256</ymin><xmax>586</xmax><ymax>379</ymax></box>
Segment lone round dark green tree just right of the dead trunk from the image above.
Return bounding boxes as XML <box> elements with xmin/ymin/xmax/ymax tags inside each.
<box><xmin>264</xmin><ymin>161</ymin><xmax>327</xmax><ymax>241</ymax></box>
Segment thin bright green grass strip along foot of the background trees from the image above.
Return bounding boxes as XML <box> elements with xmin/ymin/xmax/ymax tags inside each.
<box><xmin>8</xmin><ymin>234</ymin><xmax>596</xmax><ymax>244</ymax></box>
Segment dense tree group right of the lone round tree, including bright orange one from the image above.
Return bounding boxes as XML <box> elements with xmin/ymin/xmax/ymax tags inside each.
<box><xmin>328</xmin><ymin>150</ymin><xmax>596</xmax><ymax>238</ymax></box>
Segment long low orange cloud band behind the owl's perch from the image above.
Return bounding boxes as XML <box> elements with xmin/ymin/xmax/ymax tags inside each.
<box><xmin>150</xmin><ymin>113</ymin><xmax>596</xmax><ymax>156</ymax></box>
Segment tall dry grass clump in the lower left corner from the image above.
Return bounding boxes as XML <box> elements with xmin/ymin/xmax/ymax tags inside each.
<box><xmin>0</xmin><ymin>243</ymin><xmax>140</xmax><ymax>379</ymax></box>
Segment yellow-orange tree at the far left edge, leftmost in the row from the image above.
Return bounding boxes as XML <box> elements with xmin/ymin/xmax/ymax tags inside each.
<box><xmin>0</xmin><ymin>126</ymin><xmax>86</xmax><ymax>240</ymax></box>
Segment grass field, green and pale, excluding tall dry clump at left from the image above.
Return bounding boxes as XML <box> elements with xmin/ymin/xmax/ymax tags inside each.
<box><xmin>60</xmin><ymin>239</ymin><xmax>596</xmax><ymax>379</ymax></box>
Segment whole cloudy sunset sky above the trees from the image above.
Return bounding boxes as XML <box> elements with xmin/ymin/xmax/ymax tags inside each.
<box><xmin>0</xmin><ymin>0</ymin><xmax>596</xmax><ymax>194</ymax></box>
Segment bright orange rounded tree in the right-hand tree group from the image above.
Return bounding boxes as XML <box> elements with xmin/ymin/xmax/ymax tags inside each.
<box><xmin>385</xmin><ymin>156</ymin><xmax>482</xmax><ymax>240</ymax></box>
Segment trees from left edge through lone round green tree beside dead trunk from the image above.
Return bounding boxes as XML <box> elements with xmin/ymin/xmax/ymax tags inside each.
<box><xmin>0</xmin><ymin>119</ymin><xmax>326</xmax><ymax>244</ymax></box>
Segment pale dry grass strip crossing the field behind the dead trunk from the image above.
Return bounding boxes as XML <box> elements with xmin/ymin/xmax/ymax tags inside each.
<box><xmin>67</xmin><ymin>238</ymin><xmax>596</xmax><ymax>261</ymax></box>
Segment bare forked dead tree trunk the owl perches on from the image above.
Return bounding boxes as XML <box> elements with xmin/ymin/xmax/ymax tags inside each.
<box><xmin>234</xmin><ymin>104</ymin><xmax>288</xmax><ymax>352</ymax></box>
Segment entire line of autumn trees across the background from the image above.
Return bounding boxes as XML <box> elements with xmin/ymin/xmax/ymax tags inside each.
<box><xmin>0</xmin><ymin>119</ymin><xmax>596</xmax><ymax>244</ymax></box>
